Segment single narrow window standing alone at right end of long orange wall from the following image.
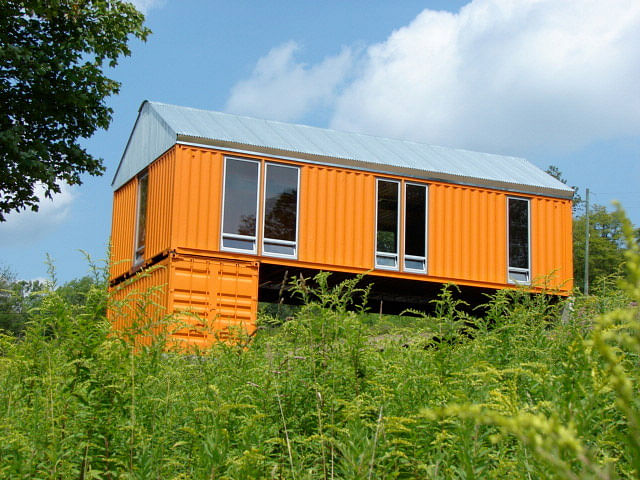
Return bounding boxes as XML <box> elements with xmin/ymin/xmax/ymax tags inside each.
<box><xmin>507</xmin><ymin>198</ymin><xmax>531</xmax><ymax>283</ymax></box>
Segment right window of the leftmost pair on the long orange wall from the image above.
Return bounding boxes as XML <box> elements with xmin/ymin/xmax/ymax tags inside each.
<box><xmin>262</xmin><ymin>163</ymin><xmax>299</xmax><ymax>257</ymax></box>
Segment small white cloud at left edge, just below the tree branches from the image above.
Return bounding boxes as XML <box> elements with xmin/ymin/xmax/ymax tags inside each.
<box><xmin>0</xmin><ymin>184</ymin><xmax>75</xmax><ymax>247</ymax></box>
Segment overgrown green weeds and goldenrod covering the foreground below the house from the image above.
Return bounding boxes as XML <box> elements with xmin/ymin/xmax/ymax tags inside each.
<box><xmin>0</xmin><ymin>218</ymin><xmax>640</xmax><ymax>479</ymax></box>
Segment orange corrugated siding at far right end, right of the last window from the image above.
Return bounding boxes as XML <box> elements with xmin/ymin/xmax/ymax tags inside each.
<box><xmin>531</xmin><ymin>197</ymin><xmax>573</xmax><ymax>292</ymax></box>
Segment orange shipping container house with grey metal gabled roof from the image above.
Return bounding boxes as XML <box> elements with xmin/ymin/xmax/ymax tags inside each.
<box><xmin>110</xmin><ymin>101</ymin><xmax>573</xmax><ymax>345</ymax></box>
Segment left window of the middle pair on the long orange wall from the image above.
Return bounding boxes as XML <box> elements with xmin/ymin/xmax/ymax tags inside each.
<box><xmin>376</xmin><ymin>180</ymin><xmax>400</xmax><ymax>270</ymax></box>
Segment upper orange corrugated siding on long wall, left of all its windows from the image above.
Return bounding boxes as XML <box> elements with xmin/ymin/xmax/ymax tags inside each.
<box><xmin>171</xmin><ymin>145</ymin><xmax>223</xmax><ymax>252</ymax></box>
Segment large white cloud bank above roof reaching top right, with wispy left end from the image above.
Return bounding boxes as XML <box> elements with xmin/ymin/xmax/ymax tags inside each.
<box><xmin>228</xmin><ymin>0</ymin><xmax>640</xmax><ymax>154</ymax></box>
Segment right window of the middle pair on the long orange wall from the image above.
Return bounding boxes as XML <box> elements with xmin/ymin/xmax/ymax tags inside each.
<box><xmin>404</xmin><ymin>183</ymin><xmax>427</xmax><ymax>272</ymax></box>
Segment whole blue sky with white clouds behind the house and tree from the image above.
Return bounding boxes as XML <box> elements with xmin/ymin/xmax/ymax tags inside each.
<box><xmin>0</xmin><ymin>0</ymin><xmax>640</xmax><ymax>282</ymax></box>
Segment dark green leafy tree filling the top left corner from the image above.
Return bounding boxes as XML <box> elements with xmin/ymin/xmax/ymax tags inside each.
<box><xmin>0</xmin><ymin>0</ymin><xmax>150</xmax><ymax>221</ymax></box>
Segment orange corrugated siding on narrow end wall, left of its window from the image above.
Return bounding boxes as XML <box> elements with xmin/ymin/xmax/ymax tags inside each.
<box><xmin>109</xmin><ymin>178</ymin><xmax>138</xmax><ymax>279</ymax></box>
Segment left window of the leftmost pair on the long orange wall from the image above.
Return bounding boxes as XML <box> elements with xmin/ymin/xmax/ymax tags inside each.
<box><xmin>222</xmin><ymin>158</ymin><xmax>260</xmax><ymax>253</ymax></box>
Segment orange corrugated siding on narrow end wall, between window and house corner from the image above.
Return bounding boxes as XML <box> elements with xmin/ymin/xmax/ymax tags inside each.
<box><xmin>145</xmin><ymin>148</ymin><xmax>176</xmax><ymax>260</ymax></box>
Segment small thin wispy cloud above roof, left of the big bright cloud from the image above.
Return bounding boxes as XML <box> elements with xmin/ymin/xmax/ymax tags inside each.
<box><xmin>226</xmin><ymin>42</ymin><xmax>353</xmax><ymax>121</ymax></box>
